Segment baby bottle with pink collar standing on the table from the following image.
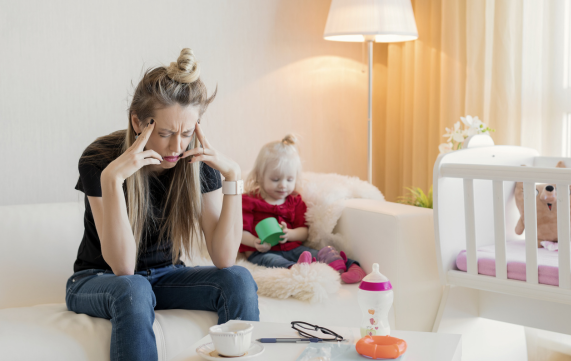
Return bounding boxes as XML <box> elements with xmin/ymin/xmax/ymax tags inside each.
<box><xmin>357</xmin><ymin>263</ymin><xmax>393</xmax><ymax>337</ymax></box>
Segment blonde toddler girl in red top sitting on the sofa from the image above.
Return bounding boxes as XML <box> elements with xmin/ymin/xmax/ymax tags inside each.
<box><xmin>239</xmin><ymin>134</ymin><xmax>366</xmax><ymax>283</ymax></box>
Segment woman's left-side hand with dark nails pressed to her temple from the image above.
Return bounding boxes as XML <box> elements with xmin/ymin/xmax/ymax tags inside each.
<box><xmin>101</xmin><ymin>119</ymin><xmax>163</xmax><ymax>183</ymax></box>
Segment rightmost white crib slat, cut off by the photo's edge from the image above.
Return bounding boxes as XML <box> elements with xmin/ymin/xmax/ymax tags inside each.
<box><xmin>557</xmin><ymin>184</ymin><xmax>571</xmax><ymax>290</ymax></box>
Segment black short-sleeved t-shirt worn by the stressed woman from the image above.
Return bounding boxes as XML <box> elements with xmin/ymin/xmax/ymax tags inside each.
<box><xmin>73</xmin><ymin>134</ymin><xmax>222</xmax><ymax>272</ymax></box>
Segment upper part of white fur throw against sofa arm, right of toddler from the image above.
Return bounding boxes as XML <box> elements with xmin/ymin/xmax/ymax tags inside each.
<box><xmin>300</xmin><ymin>172</ymin><xmax>385</xmax><ymax>251</ymax></box>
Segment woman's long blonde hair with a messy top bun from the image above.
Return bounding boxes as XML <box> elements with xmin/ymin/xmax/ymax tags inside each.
<box><xmin>80</xmin><ymin>48</ymin><xmax>216</xmax><ymax>263</ymax></box>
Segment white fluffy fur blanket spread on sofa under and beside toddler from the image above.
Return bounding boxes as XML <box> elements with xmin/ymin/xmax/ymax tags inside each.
<box><xmin>185</xmin><ymin>172</ymin><xmax>384</xmax><ymax>303</ymax></box>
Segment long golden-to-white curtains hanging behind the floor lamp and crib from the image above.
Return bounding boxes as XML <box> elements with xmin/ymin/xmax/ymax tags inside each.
<box><xmin>373</xmin><ymin>0</ymin><xmax>556</xmax><ymax>201</ymax></box>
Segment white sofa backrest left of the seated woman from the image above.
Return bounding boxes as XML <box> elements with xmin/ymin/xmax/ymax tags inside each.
<box><xmin>0</xmin><ymin>202</ymin><xmax>84</xmax><ymax>309</ymax></box>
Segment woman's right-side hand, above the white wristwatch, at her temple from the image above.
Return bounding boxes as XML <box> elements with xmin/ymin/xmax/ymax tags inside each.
<box><xmin>181</xmin><ymin>123</ymin><xmax>242</xmax><ymax>181</ymax></box>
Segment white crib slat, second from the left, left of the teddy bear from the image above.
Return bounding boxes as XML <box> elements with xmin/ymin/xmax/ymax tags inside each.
<box><xmin>493</xmin><ymin>181</ymin><xmax>508</xmax><ymax>280</ymax></box>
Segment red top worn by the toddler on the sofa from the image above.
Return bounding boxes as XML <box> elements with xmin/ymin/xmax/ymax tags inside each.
<box><xmin>238</xmin><ymin>194</ymin><xmax>307</xmax><ymax>252</ymax></box>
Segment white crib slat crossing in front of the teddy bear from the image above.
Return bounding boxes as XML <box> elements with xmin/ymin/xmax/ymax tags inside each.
<box><xmin>523</xmin><ymin>182</ymin><xmax>539</xmax><ymax>284</ymax></box>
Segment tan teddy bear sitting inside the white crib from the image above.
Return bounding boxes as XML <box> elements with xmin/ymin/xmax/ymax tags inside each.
<box><xmin>515</xmin><ymin>161</ymin><xmax>569</xmax><ymax>249</ymax></box>
